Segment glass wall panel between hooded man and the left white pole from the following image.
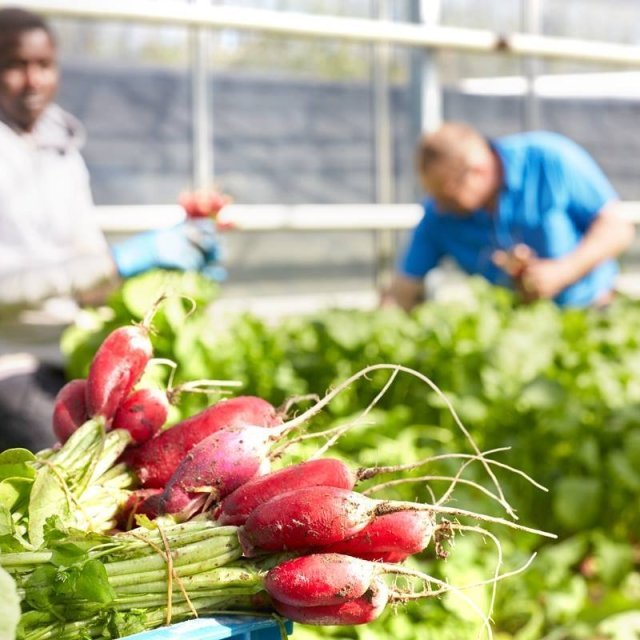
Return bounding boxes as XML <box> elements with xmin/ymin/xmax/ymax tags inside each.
<box><xmin>53</xmin><ymin>20</ymin><xmax>192</xmax><ymax>204</ymax></box>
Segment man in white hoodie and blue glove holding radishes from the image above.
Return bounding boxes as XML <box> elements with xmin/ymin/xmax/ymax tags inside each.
<box><xmin>0</xmin><ymin>8</ymin><xmax>218</xmax><ymax>450</ymax></box>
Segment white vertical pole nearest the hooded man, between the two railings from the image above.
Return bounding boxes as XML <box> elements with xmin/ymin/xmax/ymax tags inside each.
<box><xmin>189</xmin><ymin>0</ymin><xmax>213</xmax><ymax>189</ymax></box>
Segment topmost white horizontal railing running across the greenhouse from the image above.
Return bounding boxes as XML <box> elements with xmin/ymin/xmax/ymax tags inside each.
<box><xmin>12</xmin><ymin>0</ymin><xmax>640</xmax><ymax>66</ymax></box>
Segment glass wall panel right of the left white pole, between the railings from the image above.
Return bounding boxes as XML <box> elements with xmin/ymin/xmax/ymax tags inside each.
<box><xmin>211</xmin><ymin>34</ymin><xmax>375</xmax><ymax>203</ymax></box>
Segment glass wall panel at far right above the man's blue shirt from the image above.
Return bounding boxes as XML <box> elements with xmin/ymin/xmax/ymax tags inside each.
<box><xmin>538</xmin><ymin>0</ymin><xmax>640</xmax><ymax>200</ymax></box>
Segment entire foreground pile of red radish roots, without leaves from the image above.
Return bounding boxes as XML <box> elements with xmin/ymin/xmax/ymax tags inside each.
<box><xmin>53</xmin><ymin>323</ymin><xmax>544</xmax><ymax>625</ymax></box>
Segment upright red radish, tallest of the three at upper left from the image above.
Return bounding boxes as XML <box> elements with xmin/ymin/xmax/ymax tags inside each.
<box><xmin>87</xmin><ymin>325</ymin><xmax>153</xmax><ymax>425</ymax></box>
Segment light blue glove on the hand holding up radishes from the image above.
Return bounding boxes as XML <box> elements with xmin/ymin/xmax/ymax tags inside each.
<box><xmin>112</xmin><ymin>220</ymin><xmax>218</xmax><ymax>278</ymax></box>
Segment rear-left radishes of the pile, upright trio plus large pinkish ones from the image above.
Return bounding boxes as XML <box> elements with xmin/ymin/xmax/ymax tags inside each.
<box><xmin>53</xmin><ymin>323</ymin><xmax>282</xmax><ymax>515</ymax></box>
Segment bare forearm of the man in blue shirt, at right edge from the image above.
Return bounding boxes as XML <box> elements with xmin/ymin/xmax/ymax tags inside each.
<box><xmin>521</xmin><ymin>202</ymin><xmax>635</xmax><ymax>299</ymax></box>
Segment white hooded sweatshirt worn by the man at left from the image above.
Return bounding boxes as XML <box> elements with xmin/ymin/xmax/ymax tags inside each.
<box><xmin>0</xmin><ymin>105</ymin><xmax>114</xmax><ymax>362</ymax></box>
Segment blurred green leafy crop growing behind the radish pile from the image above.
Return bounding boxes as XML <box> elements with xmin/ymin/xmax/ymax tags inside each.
<box><xmin>63</xmin><ymin>274</ymin><xmax>640</xmax><ymax>640</ymax></box>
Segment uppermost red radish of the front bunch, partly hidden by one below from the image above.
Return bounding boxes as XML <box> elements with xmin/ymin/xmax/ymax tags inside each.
<box><xmin>217</xmin><ymin>458</ymin><xmax>358</xmax><ymax>525</ymax></box>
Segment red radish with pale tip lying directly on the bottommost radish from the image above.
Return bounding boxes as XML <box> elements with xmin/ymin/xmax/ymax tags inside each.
<box><xmin>264</xmin><ymin>553</ymin><xmax>379</xmax><ymax>607</ymax></box>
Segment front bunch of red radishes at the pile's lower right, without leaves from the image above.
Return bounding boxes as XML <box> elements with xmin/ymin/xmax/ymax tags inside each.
<box><xmin>219</xmin><ymin>468</ymin><xmax>436</xmax><ymax>625</ymax></box>
